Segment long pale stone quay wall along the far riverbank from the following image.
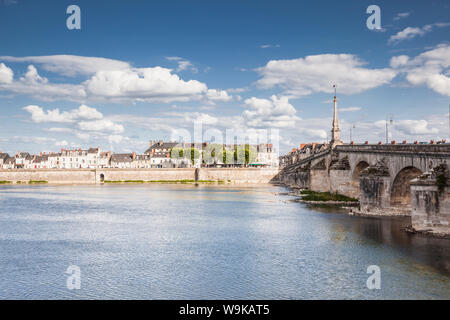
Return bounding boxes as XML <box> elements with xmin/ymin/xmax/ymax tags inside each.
<box><xmin>0</xmin><ymin>168</ymin><xmax>278</xmax><ymax>184</ymax></box>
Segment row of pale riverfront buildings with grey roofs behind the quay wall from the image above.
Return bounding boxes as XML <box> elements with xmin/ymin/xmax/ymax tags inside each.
<box><xmin>0</xmin><ymin>140</ymin><xmax>278</xmax><ymax>169</ymax></box>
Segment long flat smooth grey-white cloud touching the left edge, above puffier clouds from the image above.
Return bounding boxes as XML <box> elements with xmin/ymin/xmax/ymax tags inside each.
<box><xmin>0</xmin><ymin>55</ymin><xmax>130</xmax><ymax>76</ymax></box>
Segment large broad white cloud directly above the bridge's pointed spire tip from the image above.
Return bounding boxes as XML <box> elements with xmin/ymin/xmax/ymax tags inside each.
<box><xmin>257</xmin><ymin>54</ymin><xmax>396</xmax><ymax>97</ymax></box>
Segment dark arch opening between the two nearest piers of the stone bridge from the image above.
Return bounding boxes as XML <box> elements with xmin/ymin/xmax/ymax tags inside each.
<box><xmin>391</xmin><ymin>166</ymin><xmax>422</xmax><ymax>207</ymax></box>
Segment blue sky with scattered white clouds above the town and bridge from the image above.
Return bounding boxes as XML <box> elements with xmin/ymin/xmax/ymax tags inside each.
<box><xmin>0</xmin><ymin>0</ymin><xmax>450</xmax><ymax>154</ymax></box>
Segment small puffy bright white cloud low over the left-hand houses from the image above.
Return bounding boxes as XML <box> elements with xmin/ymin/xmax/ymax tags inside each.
<box><xmin>23</xmin><ymin>105</ymin><xmax>103</xmax><ymax>123</ymax></box>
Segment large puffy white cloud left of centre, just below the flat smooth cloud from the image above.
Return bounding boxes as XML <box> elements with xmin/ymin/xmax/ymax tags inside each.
<box><xmin>83</xmin><ymin>67</ymin><xmax>207</xmax><ymax>102</ymax></box>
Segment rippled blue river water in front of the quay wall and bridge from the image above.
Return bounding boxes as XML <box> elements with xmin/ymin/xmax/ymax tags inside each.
<box><xmin>0</xmin><ymin>184</ymin><xmax>450</xmax><ymax>299</ymax></box>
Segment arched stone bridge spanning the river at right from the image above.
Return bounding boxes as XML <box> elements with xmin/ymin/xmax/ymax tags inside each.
<box><xmin>278</xmin><ymin>143</ymin><xmax>450</xmax><ymax>220</ymax></box>
